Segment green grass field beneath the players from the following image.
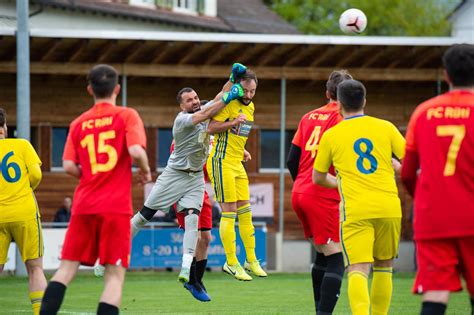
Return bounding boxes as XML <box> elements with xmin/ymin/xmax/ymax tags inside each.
<box><xmin>0</xmin><ymin>272</ymin><xmax>470</xmax><ymax>315</ymax></box>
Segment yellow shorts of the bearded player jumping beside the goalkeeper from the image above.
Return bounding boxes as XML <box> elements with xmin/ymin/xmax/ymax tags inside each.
<box><xmin>207</xmin><ymin>157</ymin><xmax>250</xmax><ymax>202</ymax></box>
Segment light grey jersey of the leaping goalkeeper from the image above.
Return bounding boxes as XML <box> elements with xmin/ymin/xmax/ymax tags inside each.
<box><xmin>168</xmin><ymin>102</ymin><xmax>211</xmax><ymax>171</ymax></box>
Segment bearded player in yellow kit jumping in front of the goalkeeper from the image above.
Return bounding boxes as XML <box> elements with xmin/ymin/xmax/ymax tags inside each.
<box><xmin>207</xmin><ymin>64</ymin><xmax>267</xmax><ymax>281</ymax></box>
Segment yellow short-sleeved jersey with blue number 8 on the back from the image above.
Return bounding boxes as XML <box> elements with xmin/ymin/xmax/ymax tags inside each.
<box><xmin>313</xmin><ymin>115</ymin><xmax>405</xmax><ymax>221</ymax></box>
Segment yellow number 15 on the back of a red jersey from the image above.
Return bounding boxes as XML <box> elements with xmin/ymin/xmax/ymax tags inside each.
<box><xmin>81</xmin><ymin>130</ymin><xmax>118</xmax><ymax>175</ymax></box>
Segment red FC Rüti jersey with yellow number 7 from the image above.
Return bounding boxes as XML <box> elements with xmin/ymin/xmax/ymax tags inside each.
<box><xmin>402</xmin><ymin>90</ymin><xmax>474</xmax><ymax>240</ymax></box>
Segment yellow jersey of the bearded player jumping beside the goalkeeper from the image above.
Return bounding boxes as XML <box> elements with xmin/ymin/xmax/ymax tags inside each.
<box><xmin>209</xmin><ymin>100</ymin><xmax>255</xmax><ymax>161</ymax></box>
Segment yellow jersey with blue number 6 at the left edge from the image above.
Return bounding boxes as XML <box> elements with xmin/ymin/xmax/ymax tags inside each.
<box><xmin>0</xmin><ymin>139</ymin><xmax>41</xmax><ymax>223</ymax></box>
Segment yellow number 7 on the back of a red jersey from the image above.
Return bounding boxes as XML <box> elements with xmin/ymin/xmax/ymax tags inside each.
<box><xmin>436</xmin><ymin>125</ymin><xmax>466</xmax><ymax>176</ymax></box>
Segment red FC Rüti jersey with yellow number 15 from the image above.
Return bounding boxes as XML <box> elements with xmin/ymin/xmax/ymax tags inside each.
<box><xmin>63</xmin><ymin>103</ymin><xmax>146</xmax><ymax>215</ymax></box>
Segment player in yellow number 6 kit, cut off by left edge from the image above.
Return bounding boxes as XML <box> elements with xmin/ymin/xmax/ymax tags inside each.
<box><xmin>0</xmin><ymin>108</ymin><xmax>46</xmax><ymax>315</ymax></box>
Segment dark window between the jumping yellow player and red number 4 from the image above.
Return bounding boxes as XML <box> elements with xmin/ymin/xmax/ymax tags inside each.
<box><xmin>260</xmin><ymin>130</ymin><xmax>295</xmax><ymax>169</ymax></box>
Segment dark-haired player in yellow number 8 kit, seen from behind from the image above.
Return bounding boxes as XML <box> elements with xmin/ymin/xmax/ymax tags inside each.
<box><xmin>313</xmin><ymin>80</ymin><xmax>405</xmax><ymax>315</ymax></box>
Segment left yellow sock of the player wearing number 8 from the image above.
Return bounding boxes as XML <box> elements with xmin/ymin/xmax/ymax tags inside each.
<box><xmin>348</xmin><ymin>271</ymin><xmax>370</xmax><ymax>315</ymax></box>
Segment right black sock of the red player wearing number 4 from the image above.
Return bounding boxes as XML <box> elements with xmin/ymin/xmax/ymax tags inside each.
<box><xmin>318</xmin><ymin>253</ymin><xmax>344</xmax><ymax>314</ymax></box>
